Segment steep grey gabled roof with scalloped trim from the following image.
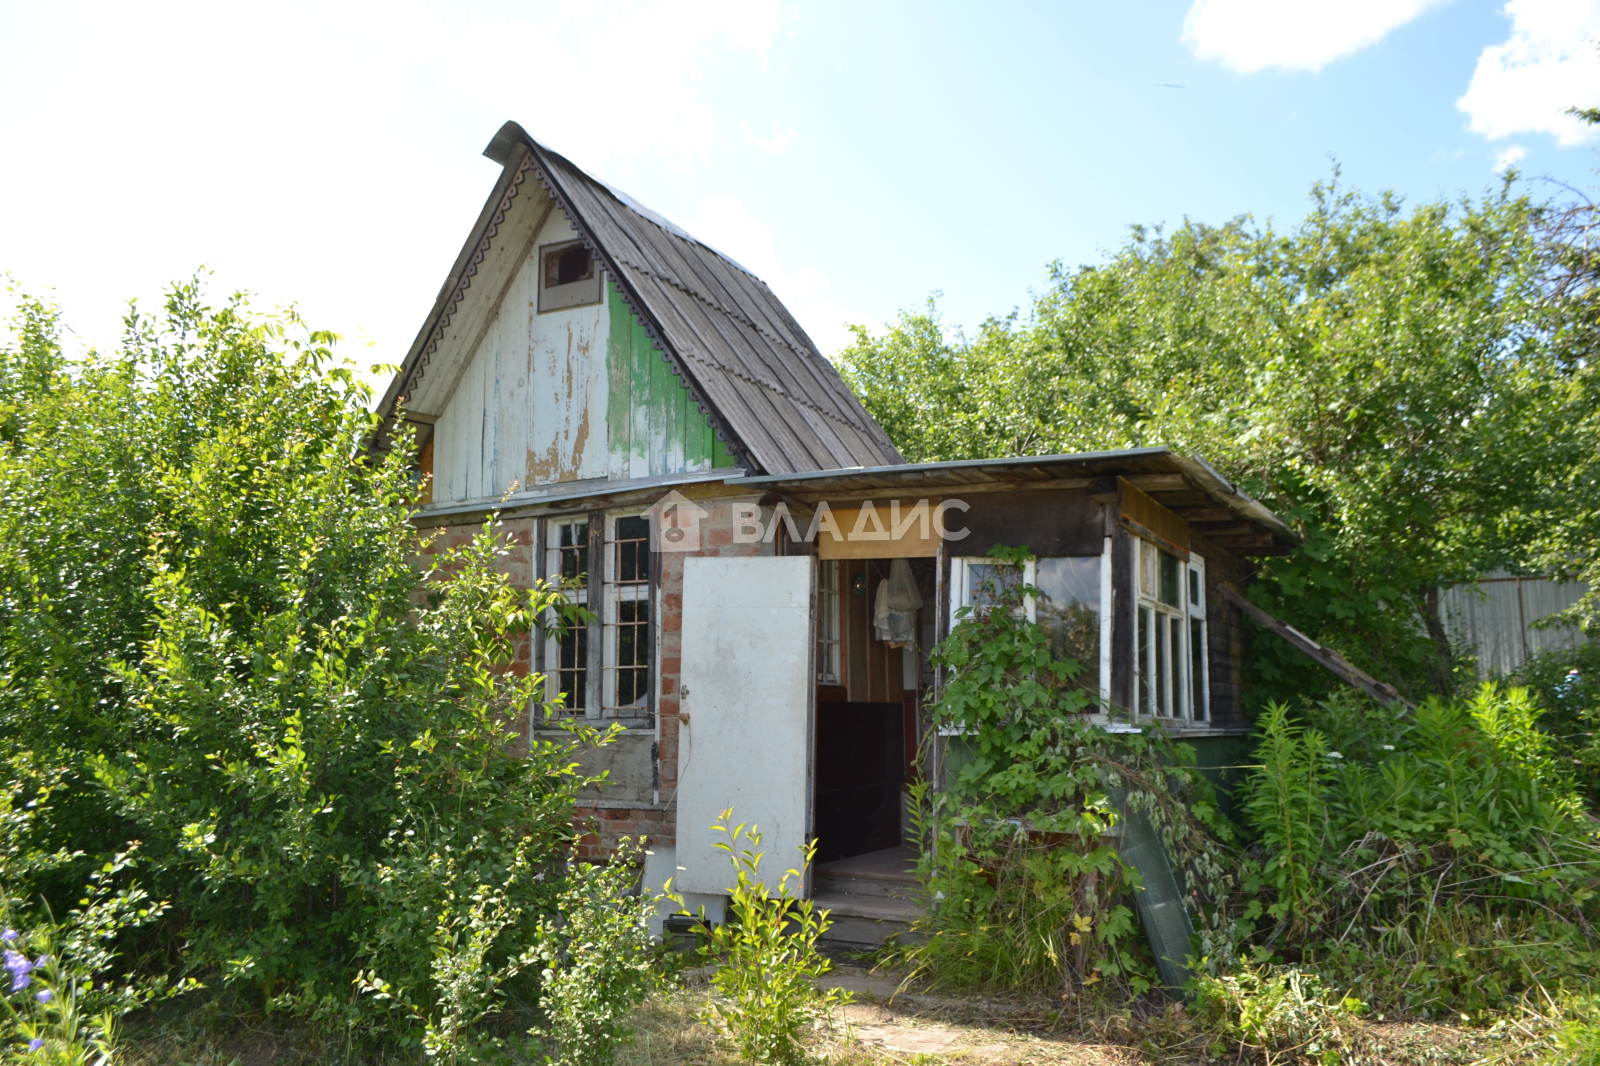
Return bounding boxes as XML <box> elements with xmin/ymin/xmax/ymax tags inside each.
<box><xmin>379</xmin><ymin>122</ymin><xmax>904</xmax><ymax>474</ymax></box>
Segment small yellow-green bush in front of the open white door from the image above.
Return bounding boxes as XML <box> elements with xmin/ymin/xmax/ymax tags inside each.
<box><xmin>674</xmin><ymin>810</ymin><xmax>850</xmax><ymax>1066</ymax></box>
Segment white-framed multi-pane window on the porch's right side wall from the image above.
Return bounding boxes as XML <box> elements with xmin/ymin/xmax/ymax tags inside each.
<box><xmin>1134</xmin><ymin>539</ymin><xmax>1208</xmax><ymax>722</ymax></box>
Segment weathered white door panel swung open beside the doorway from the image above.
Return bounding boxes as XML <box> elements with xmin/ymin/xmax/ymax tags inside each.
<box><xmin>677</xmin><ymin>555</ymin><xmax>811</xmax><ymax>895</ymax></box>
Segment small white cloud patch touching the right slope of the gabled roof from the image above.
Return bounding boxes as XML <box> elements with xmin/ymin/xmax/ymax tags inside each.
<box><xmin>683</xmin><ymin>192</ymin><xmax>867</xmax><ymax>355</ymax></box>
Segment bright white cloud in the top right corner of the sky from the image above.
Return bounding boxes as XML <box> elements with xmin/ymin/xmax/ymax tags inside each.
<box><xmin>1456</xmin><ymin>0</ymin><xmax>1600</xmax><ymax>146</ymax></box>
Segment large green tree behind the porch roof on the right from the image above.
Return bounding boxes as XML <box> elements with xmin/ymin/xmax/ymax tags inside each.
<box><xmin>840</xmin><ymin>179</ymin><xmax>1592</xmax><ymax>703</ymax></box>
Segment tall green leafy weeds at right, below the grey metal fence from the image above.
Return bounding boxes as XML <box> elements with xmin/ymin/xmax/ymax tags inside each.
<box><xmin>1245</xmin><ymin>685</ymin><xmax>1600</xmax><ymax>1013</ymax></box>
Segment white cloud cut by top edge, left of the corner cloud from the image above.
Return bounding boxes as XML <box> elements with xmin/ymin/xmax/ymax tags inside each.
<box><xmin>1182</xmin><ymin>0</ymin><xmax>1448</xmax><ymax>74</ymax></box>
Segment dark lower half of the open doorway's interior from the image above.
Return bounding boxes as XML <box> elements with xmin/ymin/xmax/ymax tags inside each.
<box><xmin>814</xmin><ymin>703</ymin><xmax>906</xmax><ymax>863</ymax></box>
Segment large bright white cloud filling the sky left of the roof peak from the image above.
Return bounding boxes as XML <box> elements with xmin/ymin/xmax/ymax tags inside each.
<box><xmin>0</xmin><ymin>0</ymin><xmax>786</xmax><ymax>362</ymax></box>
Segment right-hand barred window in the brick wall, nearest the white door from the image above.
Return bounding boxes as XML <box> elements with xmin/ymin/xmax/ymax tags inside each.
<box><xmin>600</xmin><ymin>515</ymin><xmax>654</xmax><ymax>719</ymax></box>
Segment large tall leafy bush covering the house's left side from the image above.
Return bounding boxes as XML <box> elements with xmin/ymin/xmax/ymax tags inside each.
<box><xmin>0</xmin><ymin>285</ymin><xmax>605</xmax><ymax>1053</ymax></box>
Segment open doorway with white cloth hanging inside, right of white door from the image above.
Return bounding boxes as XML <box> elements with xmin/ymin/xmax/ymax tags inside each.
<box><xmin>811</xmin><ymin>559</ymin><xmax>934</xmax><ymax>864</ymax></box>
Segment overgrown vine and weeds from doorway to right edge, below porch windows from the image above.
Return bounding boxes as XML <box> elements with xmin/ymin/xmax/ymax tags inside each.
<box><xmin>904</xmin><ymin>549</ymin><xmax>1600</xmax><ymax>1024</ymax></box>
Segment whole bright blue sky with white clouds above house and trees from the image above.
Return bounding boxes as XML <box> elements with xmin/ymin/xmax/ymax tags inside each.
<box><xmin>0</xmin><ymin>0</ymin><xmax>1600</xmax><ymax>362</ymax></box>
